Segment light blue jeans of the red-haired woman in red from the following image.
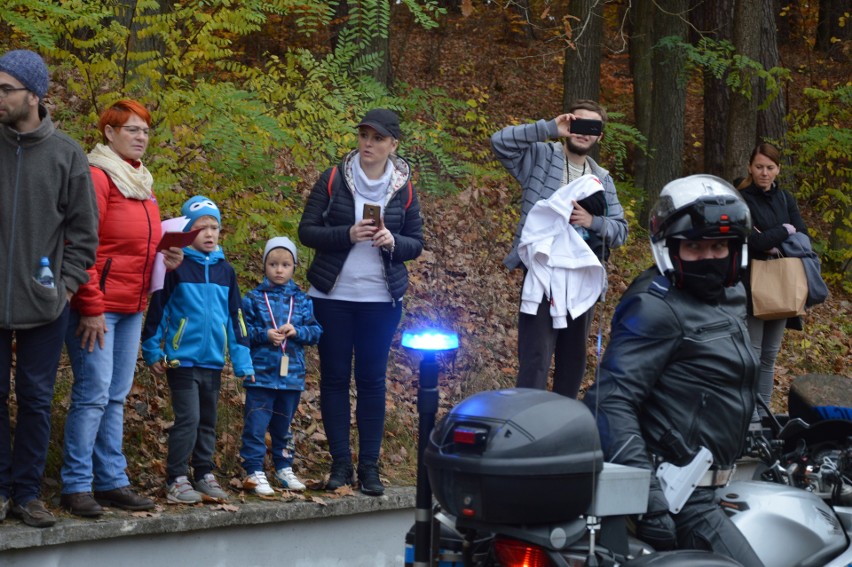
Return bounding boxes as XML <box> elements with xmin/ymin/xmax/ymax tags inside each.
<box><xmin>61</xmin><ymin>311</ymin><xmax>142</xmax><ymax>494</ymax></box>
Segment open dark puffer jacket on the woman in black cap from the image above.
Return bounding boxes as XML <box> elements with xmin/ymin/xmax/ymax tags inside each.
<box><xmin>299</xmin><ymin>150</ymin><xmax>423</xmax><ymax>301</ymax></box>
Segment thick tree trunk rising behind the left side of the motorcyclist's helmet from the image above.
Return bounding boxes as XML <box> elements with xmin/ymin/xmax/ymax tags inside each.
<box><xmin>642</xmin><ymin>0</ymin><xmax>688</xmax><ymax>219</ymax></box>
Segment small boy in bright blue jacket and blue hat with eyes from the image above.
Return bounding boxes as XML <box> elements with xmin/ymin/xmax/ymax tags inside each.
<box><xmin>142</xmin><ymin>196</ymin><xmax>254</xmax><ymax>504</ymax></box>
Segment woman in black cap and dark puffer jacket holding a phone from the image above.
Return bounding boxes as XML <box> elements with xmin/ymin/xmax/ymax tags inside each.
<box><xmin>299</xmin><ymin>109</ymin><xmax>423</xmax><ymax>496</ymax></box>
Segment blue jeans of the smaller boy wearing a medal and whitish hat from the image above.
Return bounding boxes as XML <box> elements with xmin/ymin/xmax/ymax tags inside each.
<box><xmin>240</xmin><ymin>387</ymin><xmax>302</xmax><ymax>474</ymax></box>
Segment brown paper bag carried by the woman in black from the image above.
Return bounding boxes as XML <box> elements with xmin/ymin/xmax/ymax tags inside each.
<box><xmin>749</xmin><ymin>258</ymin><xmax>808</xmax><ymax>320</ymax></box>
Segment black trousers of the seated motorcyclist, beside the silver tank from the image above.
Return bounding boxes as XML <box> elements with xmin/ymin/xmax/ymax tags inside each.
<box><xmin>672</xmin><ymin>488</ymin><xmax>763</xmax><ymax>567</ymax></box>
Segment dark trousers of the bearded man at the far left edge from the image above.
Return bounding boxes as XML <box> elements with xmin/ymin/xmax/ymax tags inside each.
<box><xmin>0</xmin><ymin>305</ymin><xmax>69</xmax><ymax>506</ymax></box>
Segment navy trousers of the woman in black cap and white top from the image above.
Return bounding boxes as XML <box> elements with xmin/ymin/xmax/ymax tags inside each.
<box><xmin>313</xmin><ymin>298</ymin><xmax>402</xmax><ymax>463</ymax></box>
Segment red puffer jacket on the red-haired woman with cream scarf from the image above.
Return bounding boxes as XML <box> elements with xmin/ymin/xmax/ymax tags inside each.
<box><xmin>71</xmin><ymin>166</ymin><xmax>162</xmax><ymax>317</ymax></box>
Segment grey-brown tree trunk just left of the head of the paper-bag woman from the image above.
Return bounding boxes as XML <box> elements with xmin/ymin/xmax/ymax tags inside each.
<box><xmin>723</xmin><ymin>0</ymin><xmax>772</xmax><ymax>181</ymax></box>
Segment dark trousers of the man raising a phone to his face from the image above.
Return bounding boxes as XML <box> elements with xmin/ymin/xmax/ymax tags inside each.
<box><xmin>518</xmin><ymin>297</ymin><xmax>595</xmax><ymax>399</ymax></box>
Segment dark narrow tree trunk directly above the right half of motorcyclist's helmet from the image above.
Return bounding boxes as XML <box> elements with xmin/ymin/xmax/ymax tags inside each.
<box><xmin>701</xmin><ymin>0</ymin><xmax>734</xmax><ymax>177</ymax></box>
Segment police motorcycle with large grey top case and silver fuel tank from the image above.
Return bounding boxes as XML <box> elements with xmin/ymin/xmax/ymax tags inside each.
<box><xmin>416</xmin><ymin>382</ymin><xmax>852</xmax><ymax>567</ymax></box>
